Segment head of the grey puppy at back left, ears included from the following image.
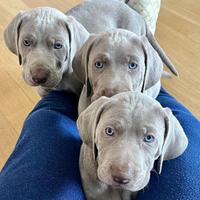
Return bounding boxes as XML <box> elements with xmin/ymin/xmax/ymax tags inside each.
<box><xmin>4</xmin><ymin>7</ymin><xmax>88</xmax><ymax>88</ymax></box>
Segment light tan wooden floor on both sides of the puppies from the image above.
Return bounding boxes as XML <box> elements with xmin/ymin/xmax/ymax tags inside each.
<box><xmin>0</xmin><ymin>0</ymin><xmax>200</xmax><ymax>169</ymax></box>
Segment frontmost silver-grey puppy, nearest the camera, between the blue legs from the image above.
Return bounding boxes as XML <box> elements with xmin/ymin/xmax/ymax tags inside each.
<box><xmin>77</xmin><ymin>92</ymin><xmax>188</xmax><ymax>200</ymax></box>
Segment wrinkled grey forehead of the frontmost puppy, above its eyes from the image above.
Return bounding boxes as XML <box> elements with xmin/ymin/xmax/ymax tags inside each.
<box><xmin>99</xmin><ymin>94</ymin><xmax>164</xmax><ymax>128</ymax></box>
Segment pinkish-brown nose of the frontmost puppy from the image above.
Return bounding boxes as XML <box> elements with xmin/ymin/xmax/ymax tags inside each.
<box><xmin>111</xmin><ymin>163</ymin><xmax>130</xmax><ymax>184</ymax></box>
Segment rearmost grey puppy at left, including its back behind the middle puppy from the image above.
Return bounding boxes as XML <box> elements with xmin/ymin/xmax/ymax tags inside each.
<box><xmin>4</xmin><ymin>0</ymin><xmax>176</xmax><ymax>96</ymax></box>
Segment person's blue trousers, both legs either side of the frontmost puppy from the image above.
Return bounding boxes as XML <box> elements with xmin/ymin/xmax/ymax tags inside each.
<box><xmin>0</xmin><ymin>89</ymin><xmax>200</xmax><ymax>200</ymax></box>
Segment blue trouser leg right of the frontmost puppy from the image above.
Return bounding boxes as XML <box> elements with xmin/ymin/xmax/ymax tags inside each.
<box><xmin>137</xmin><ymin>89</ymin><xmax>200</xmax><ymax>200</ymax></box>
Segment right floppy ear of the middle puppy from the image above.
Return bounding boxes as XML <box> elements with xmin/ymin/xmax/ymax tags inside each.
<box><xmin>142</xmin><ymin>36</ymin><xmax>163</xmax><ymax>92</ymax></box>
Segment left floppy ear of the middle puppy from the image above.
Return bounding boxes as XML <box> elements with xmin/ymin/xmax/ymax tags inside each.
<box><xmin>72</xmin><ymin>35</ymin><xmax>96</xmax><ymax>96</ymax></box>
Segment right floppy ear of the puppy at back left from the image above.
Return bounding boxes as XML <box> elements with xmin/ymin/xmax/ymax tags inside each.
<box><xmin>65</xmin><ymin>16</ymin><xmax>89</xmax><ymax>63</ymax></box>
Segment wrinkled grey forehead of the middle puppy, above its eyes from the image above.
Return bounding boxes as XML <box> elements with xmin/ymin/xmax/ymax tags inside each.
<box><xmin>91</xmin><ymin>32</ymin><xmax>143</xmax><ymax>56</ymax></box>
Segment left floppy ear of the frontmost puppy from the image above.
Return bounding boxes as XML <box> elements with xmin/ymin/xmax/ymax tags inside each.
<box><xmin>77</xmin><ymin>96</ymin><xmax>110</xmax><ymax>158</ymax></box>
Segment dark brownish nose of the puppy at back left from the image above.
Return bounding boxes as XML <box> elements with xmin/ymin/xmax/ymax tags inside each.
<box><xmin>31</xmin><ymin>68</ymin><xmax>50</xmax><ymax>84</ymax></box>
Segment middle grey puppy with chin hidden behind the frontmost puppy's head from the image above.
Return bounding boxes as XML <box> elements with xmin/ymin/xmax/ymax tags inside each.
<box><xmin>72</xmin><ymin>29</ymin><xmax>176</xmax><ymax>113</ymax></box>
